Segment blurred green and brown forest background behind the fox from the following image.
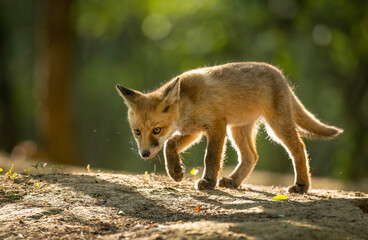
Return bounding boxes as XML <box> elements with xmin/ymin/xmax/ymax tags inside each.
<box><xmin>0</xmin><ymin>0</ymin><xmax>368</xmax><ymax>180</ymax></box>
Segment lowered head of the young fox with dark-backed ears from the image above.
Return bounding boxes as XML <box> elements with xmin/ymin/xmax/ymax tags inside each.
<box><xmin>116</xmin><ymin>77</ymin><xmax>180</xmax><ymax>159</ymax></box>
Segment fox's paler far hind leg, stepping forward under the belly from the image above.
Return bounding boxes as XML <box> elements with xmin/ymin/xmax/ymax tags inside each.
<box><xmin>219</xmin><ymin>123</ymin><xmax>258</xmax><ymax>188</ymax></box>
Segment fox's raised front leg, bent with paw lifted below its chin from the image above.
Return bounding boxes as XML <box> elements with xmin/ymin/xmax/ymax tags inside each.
<box><xmin>164</xmin><ymin>132</ymin><xmax>201</xmax><ymax>182</ymax></box>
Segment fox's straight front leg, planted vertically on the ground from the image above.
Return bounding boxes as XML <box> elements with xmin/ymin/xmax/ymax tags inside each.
<box><xmin>195</xmin><ymin>123</ymin><xmax>226</xmax><ymax>190</ymax></box>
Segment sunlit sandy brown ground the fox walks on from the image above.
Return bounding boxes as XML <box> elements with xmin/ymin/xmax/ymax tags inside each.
<box><xmin>0</xmin><ymin>170</ymin><xmax>368</xmax><ymax>239</ymax></box>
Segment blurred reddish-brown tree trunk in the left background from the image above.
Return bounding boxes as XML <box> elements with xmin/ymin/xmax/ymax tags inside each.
<box><xmin>36</xmin><ymin>0</ymin><xmax>80</xmax><ymax>164</ymax></box>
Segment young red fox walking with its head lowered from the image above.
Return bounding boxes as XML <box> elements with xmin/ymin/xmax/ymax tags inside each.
<box><xmin>116</xmin><ymin>62</ymin><xmax>343</xmax><ymax>193</ymax></box>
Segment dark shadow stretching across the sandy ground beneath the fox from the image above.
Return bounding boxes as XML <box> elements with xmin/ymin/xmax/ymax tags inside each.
<box><xmin>30</xmin><ymin>174</ymin><xmax>368</xmax><ymax>226</ymax></box>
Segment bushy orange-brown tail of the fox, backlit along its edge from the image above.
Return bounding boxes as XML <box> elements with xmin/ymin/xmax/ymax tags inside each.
<box><xmin>293</xmin><ymin>95</ymin><xmax>344</xmax><ymax>139</ymax></box>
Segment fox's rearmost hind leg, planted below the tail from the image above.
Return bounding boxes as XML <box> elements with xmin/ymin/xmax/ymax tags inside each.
<box><xmin>267</xmin><ymin>116</ymin><xmax>311</xmax><ymax>193</ymax></box>
